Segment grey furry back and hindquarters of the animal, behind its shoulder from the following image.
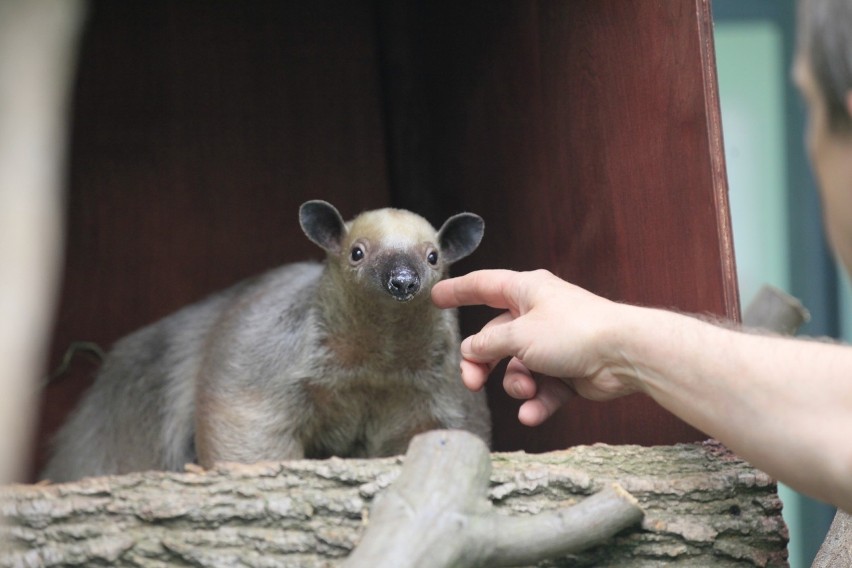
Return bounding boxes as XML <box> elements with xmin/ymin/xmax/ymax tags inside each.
<box><xmin>41</xmin><ymin>263</ymin><xmax>322</xmax><ymax>482</ymax></box>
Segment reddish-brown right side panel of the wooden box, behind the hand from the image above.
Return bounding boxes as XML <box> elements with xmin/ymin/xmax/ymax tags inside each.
<box><xmin>382</xmin><ymin>0</ymin><xmax>739</xmax><ymax>451</ymax></box>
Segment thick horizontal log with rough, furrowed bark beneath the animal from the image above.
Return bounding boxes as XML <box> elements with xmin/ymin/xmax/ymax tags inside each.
<box><xmin>0</xmin><ymin>442</ymin><xmax>787</xmax><ymax>567</ymax></box>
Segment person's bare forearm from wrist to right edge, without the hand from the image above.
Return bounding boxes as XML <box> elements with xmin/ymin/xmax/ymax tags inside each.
<box><xmin>614</xmin><ymin>306</ymin><xmax>852</xmax><ymax>510</ymax></box>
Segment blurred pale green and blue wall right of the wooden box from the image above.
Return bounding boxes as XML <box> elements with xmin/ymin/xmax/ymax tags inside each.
<box><xmin>714</xmin><ymin>6</ymin><xmax>836</xmax><ymax>568</ymax></box>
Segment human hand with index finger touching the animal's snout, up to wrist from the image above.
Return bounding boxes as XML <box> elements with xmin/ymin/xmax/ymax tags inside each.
<box><xmin>432</xmin><ymin>270</ymin><xmax>639</xmax><ymax>426</ymax></box>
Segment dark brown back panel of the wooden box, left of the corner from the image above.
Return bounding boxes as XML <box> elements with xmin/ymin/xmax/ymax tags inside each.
<box><xmin>39</xmin><ymin>1</ymin><xmax>389</xmax><ymax>474</ymax></box>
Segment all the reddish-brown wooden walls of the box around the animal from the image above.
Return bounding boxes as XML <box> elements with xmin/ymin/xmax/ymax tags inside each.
<box><xmin>36</xmin><ymin>0</ymin><xmax>739</xmax><ymax>478</ymax></box>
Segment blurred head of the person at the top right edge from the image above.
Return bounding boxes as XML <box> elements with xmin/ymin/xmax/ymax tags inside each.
<box><xmin>793</xmin><ymin>0</ymin><xmax>852</xmax><ymax>273</ymax></box>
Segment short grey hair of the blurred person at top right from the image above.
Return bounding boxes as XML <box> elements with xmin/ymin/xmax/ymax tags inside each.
<box><xmin>798</xmin><ymin>0</ymin><xmax>852</xmax><ymax>134</ymax></box>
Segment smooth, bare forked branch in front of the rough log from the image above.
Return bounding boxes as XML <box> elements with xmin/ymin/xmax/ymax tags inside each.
<box><xmin>344</xmin><ymin>430</ymin><xmax>643</xmax><ymax>568</ymax></box>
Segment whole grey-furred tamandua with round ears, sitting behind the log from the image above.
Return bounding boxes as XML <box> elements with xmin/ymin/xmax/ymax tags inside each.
<box><xmin>42</xmin><ymin>201</ymin><xmax>491</xmax><ymax>481</ymax></box>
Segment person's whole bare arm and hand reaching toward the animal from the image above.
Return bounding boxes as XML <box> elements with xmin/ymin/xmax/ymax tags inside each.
<box><xmin>433</xmin><ymin>271</ymin><xmax>852</xmax><ymax>511</ymax></box>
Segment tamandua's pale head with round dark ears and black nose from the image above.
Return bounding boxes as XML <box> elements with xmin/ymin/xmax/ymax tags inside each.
<box><xmin>299</xmin><ymin>200</ymin><xmax>485</xmax><ymax>302</ymax></box>
